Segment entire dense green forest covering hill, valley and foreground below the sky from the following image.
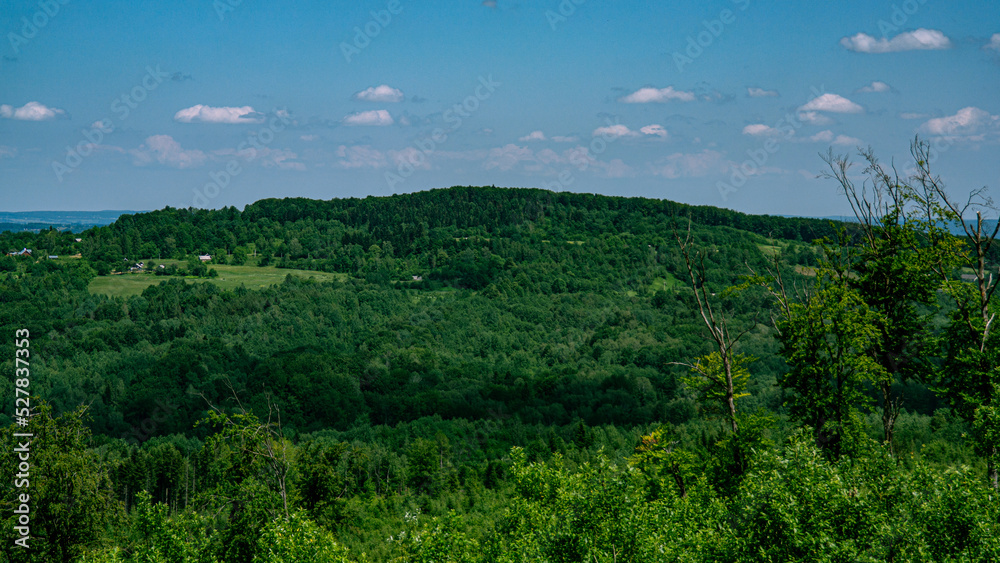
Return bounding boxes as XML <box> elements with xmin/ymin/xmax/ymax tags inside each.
<box><xmin>0</xmin><ymin>142</ymin><xmax>1000</xmax><ymax>563</ymax></box>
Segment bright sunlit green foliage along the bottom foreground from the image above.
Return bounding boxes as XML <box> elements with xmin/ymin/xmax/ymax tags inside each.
<box><xmin>64</xmin><ymin>429</ymin><xmax>1000</xmax><ymax>563</ymax></box>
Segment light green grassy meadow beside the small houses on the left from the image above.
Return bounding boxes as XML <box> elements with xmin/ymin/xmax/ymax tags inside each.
<box><xmin>87</xmin><ymin>261</ymin><xmax>347</xmax><ymax>297</ymax></box>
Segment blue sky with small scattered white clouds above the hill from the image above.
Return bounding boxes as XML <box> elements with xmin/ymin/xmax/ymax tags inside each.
<box><xmin>0</xmin><ymin>0</ymin><xmax>1000</xmax><ymax>216</ymax></box>
